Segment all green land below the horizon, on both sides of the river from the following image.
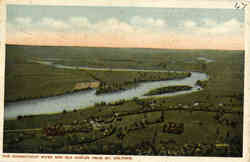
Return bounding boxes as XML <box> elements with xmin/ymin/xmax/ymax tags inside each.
<box><xmin>4</xmin><ymin>46</ymin><xmax>244</xmax><ymax>157</ymax></box>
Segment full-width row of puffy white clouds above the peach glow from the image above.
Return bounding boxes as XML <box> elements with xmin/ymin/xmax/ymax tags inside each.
<box><xmin>8</xmin><ymin>16</ymin><xmax>243</xmax><ymax>35</ymax></box>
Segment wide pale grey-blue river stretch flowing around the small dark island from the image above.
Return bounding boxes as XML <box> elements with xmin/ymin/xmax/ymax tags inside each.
<box><xmin>4</xmin><ymin>72</ymin><xmax>208</xmax><ymax>119</ymax></box>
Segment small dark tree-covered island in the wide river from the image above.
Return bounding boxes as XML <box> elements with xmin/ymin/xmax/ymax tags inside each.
<box><xmin>144</xmin><ymin>85</ymin><xmax>192</xmax><ymax>96</ymax></box>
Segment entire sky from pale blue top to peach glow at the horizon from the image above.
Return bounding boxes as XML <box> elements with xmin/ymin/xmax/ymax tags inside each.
<box><xmin>7</xmin><ymin>5</ymin><xmax>244</xmax><ymax>50</ymax></box>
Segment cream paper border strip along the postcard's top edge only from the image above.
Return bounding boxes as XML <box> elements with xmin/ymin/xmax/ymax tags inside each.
<box><xmin>6</xmin><ymin>0</ymin><xmax>234</xmax><ymax>8</ymax></box>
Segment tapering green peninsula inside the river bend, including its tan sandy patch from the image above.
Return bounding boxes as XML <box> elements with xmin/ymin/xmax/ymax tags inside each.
<box><xmin>5</xmin><ymin>52</ymin><xmax>191</xmax><ymax>103</ymax></box>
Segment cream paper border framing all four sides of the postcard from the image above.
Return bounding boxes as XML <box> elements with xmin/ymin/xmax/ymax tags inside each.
<box><xmin>0</xmin><ymin>0</ymin><xmax>250</xmax><ymax>162</ymax></box>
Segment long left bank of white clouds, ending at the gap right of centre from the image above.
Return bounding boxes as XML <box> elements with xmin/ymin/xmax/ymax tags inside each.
<box><xmin>8</xmin><ymin>17</ymin><xmax>157</xmax><ymax>34</ymax></box>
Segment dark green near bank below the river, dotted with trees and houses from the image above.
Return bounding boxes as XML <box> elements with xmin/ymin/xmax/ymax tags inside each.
<box><xmin>4</xmin><ymin>91</ymin><xmax>242</xmax><ymax>156</ymax></box>
